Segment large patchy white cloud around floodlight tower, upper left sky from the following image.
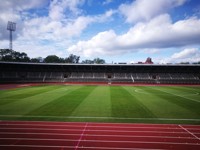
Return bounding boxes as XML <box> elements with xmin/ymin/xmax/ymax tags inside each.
<box><xmin>0</xmin><ymin>0</ymin><xmax>116</xmax><ymax>57</ymax></box>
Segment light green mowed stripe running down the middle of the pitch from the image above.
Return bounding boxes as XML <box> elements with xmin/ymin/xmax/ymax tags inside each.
<box><xmin>71</xmin><ymin>86</ymin><xmax>112</xmax><ymax>117</ymax></box>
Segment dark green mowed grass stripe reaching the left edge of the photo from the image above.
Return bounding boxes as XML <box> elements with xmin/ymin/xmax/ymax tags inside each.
<box><xmin>0</xmin><ymin>86</ymin><xmax>65</xmax><ymax>105</ymax></box>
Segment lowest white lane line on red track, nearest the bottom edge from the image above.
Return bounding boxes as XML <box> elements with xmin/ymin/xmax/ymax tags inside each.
<box><xmin>0</xmin><ymin>145</ymin><xmax>164</xmax><ymax>150</ymax></box>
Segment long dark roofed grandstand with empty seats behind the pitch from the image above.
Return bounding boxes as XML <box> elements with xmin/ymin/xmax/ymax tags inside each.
<box><xmin>0</xmin><ymin>62</ymin><xmax>200</xmax><ymax>84</ymax></box>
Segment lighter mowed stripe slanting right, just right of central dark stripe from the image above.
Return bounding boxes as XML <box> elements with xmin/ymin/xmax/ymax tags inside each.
<box><xmin>132</xmin><ymin>86</ymin><xmax>198</xmax><ymax>119</ymax></box>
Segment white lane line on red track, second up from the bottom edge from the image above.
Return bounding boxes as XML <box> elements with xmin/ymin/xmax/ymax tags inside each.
<box><xmin>0</xmin><ymin>138</ymin><xmax>200</xmax><ymax>145</ymax></box>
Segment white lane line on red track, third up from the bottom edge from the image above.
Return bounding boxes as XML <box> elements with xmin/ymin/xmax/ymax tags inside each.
<box><xmin>0</xmin><ymin>132</ymin><xmax>196</xmax><ymax>139</ymax></box>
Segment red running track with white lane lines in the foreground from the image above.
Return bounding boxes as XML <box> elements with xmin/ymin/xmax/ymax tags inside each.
<box><xmin>0</xmin><ymin>121</ymin><xmax>200</xmax><ymax>150</ymax></box>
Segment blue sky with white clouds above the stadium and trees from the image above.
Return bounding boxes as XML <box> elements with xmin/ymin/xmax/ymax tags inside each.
<box><xmin>0</xmin><ymin>0</ymin><xmax>200</xmax><ymax>64</ymax></box>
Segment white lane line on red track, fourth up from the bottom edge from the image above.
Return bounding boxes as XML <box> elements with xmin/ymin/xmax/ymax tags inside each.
<box><xmin>1</xmin><ymin>128</ymin><xmax>197</xmax><ymax>134</ymax></box>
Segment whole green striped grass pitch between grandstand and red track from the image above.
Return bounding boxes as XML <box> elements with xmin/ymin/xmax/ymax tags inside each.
<box><xmin>0</xmin><ymin>85</ymin><xmax>200</xmax><ymax>124</ymax></box>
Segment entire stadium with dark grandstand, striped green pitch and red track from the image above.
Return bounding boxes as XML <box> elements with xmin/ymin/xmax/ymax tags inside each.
<box><xmin>0</xmin><ymin>62</ymin><xmax>200</xmax><ymax>150</ymax></box>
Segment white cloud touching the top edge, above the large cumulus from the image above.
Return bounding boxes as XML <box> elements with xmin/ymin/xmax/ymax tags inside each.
<box><xmin>119</xmin><ymin>0</ymin><xmax>187</xmax><ymax>23</ymax></box>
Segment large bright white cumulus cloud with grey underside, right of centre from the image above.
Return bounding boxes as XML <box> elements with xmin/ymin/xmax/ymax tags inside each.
<box><xmin>68</xmin><ymin>14</ymin><xmax>200</xmax><ymax>57</ymax></box>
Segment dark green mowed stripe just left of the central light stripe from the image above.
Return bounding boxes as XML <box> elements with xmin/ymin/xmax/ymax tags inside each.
<box><xmin>26</xmin><ymin>86</ymin><xmax>95</xmax><ymax>116</ymax></box>
